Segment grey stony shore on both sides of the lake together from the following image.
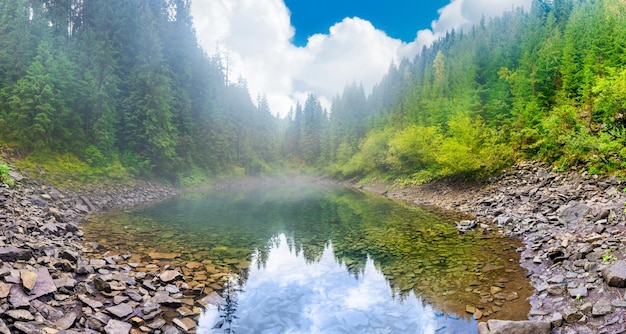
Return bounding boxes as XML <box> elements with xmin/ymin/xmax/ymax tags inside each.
<box><xmin>0</xmin><ymin>163</ymin><xmax>626</xmax><ymax>334</ymax></box>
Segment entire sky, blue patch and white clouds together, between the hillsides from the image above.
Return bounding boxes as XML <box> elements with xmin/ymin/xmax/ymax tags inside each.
<box><xmin>191</xmin><ymin>0</ymin><xmax>532</xmax><ymax>115</ymax></box>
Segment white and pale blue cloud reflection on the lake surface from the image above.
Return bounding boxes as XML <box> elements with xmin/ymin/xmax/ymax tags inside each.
<box><xmin>198</xmin><ymin>234</ymin><xmax>477</xmax><ymax>334</ymax></box>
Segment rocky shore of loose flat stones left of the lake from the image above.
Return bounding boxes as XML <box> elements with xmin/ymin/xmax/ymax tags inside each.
<box><xmin>0</xmin><ymin>173</ymin><xmax>228</xmax><ymax>334</ymax></box>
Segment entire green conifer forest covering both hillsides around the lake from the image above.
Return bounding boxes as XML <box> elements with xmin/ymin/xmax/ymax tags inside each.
<box><xmin>0</xmin><ymin>0</ymin><xmax>626</xmax><ymax>183</ymax></box>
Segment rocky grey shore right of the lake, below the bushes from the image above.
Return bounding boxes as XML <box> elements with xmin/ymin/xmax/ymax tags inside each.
<box><xmin>363</xmin><ymin>163</ymin><xmax>626</xmax><ymax>334</ymax></box>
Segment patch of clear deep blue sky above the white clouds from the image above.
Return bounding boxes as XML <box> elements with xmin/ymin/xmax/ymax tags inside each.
<box><xmin>285</xmin><ymin>0</ymin><xmax>450</xmax><ymax>46</ymax></box>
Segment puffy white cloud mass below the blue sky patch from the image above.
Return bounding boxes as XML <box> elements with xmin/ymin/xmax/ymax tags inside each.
<box><xmin>192</xmin><ymin>0</ymin><xmax>532</xmax><ymax>115</ymax></box>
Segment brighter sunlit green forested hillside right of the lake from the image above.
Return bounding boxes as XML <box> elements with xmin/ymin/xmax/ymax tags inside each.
<box><xmin>322</xmin><ymin>0</ymin><xmax>626</xmax><ymax>182</ymax></box>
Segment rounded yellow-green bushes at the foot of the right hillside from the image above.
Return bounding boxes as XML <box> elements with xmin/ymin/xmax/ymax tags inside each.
<box><xmin>339</xmin><ymin>113</ymin><xmax>514</xmax><ymax>183</ymax></box>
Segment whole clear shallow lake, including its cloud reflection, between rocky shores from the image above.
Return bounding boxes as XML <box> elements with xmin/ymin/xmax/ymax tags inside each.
<box><xmin>85</xmin><ymin>180</ymin><xmax>530</xmax><ymax>333</ymax></box>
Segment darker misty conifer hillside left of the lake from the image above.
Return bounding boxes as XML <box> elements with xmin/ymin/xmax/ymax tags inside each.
<box><xmin>0</xmin><ymin>0</ymin><xmax>280</xmax><ymax>183</ymax></box>
